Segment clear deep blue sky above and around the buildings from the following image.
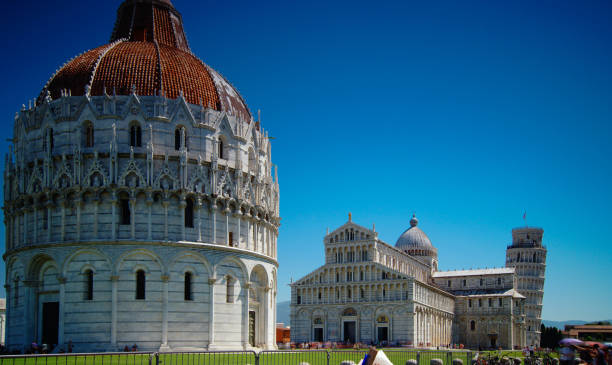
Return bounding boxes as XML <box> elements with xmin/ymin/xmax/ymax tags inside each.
<box><xmin>0</xmin><ymin>0</ymin><xmax>612</xmax><ymax>320</ymax></box>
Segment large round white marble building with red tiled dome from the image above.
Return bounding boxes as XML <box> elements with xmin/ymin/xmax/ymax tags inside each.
<box><xmin>4</xmin><ymin>0</ymin><xmax>280</xmax><ymax>352</ymax></box>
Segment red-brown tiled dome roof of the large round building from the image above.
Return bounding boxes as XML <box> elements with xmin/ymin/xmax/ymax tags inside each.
<box><xmin>39</xmin><ymin>0</ymin><xmax>251</xmax><ymax>121</ymax></box>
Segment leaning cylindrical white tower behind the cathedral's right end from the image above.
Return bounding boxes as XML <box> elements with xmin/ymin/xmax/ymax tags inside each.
<box><xmin>506</xmin><ymin>227</ymin><xmax>546</xmax><ymax>346</ymax></box>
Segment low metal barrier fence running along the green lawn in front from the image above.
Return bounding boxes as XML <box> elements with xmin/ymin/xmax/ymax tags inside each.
<box><xmin>0</xmin><ymin>348</ymin><xmax>474</xmax><ymax>365</ymax></box>
